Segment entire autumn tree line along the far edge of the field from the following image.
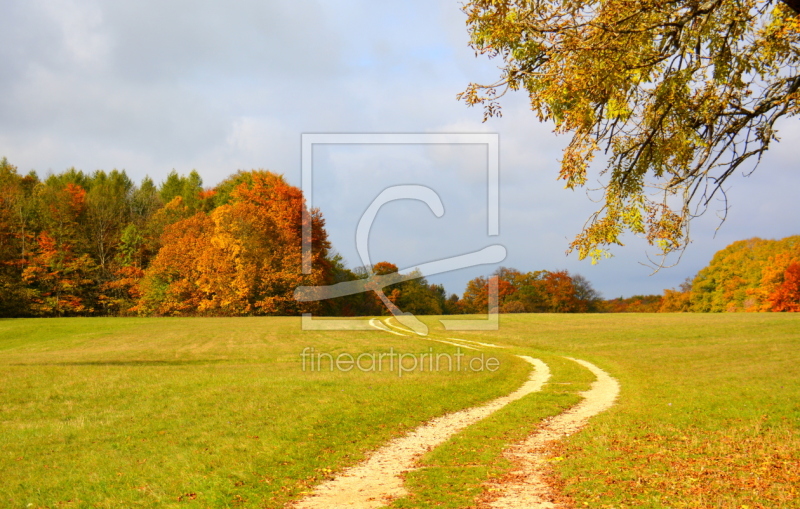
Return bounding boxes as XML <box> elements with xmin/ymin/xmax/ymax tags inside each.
<box><xmin>0</xmin><ymin>158</ymin><xmax>800</xmax><ymax>317</ymax></box>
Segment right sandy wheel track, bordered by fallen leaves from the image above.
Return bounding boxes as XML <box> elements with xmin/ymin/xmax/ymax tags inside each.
<box><xmin>479</xmin><ymin>359</ymin><xmax>619</xmax><ymax>509</ymax></box>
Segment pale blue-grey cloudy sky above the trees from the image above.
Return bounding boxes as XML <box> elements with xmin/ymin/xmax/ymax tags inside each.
<box><xmin>0</xmin><ymin>0</ymin><xmax>800</xmax><ymax>298</ymax></box>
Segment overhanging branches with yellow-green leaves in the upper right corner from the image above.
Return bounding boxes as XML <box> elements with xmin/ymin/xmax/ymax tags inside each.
<box><xmin>458</xmin><ymin>0</ymin><xmax>800</xmax><ymax>265</ymax></box>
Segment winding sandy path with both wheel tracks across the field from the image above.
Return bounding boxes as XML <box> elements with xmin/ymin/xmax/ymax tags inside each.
<box><xmin>290</xmin><ymin>322</ymin><xmax>619</xmax><ymax>509</ymax></box>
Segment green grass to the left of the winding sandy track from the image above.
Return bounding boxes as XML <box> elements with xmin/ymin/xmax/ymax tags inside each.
<box><xmin>0</xmin><ymin>318</ymin><xmax>528</xmax><ymax>507</ymax></box>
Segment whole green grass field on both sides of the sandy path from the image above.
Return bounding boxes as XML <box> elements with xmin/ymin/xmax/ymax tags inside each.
<box><xmin>0</xmin><ymin>314</ymin><xmax>800</xmax><ymax>508</ymax></box>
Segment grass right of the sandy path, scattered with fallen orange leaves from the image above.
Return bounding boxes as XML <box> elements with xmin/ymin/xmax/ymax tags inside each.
<box><xmin>432</xmin><ymin>313</ymin><xmax>800</xmax><ymax>508</ymax></box>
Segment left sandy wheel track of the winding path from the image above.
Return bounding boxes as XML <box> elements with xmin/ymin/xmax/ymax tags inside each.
<box><xmin>293</xmin><ymin>356</ymin><xmax>552</xmax><ymax>509</ymax></box>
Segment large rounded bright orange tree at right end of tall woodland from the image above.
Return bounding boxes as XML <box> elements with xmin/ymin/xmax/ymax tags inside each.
<box><xmin>136</xmin><ymin>171</ymin><xmax>330</xmax><ymax>315</ymax></box>
